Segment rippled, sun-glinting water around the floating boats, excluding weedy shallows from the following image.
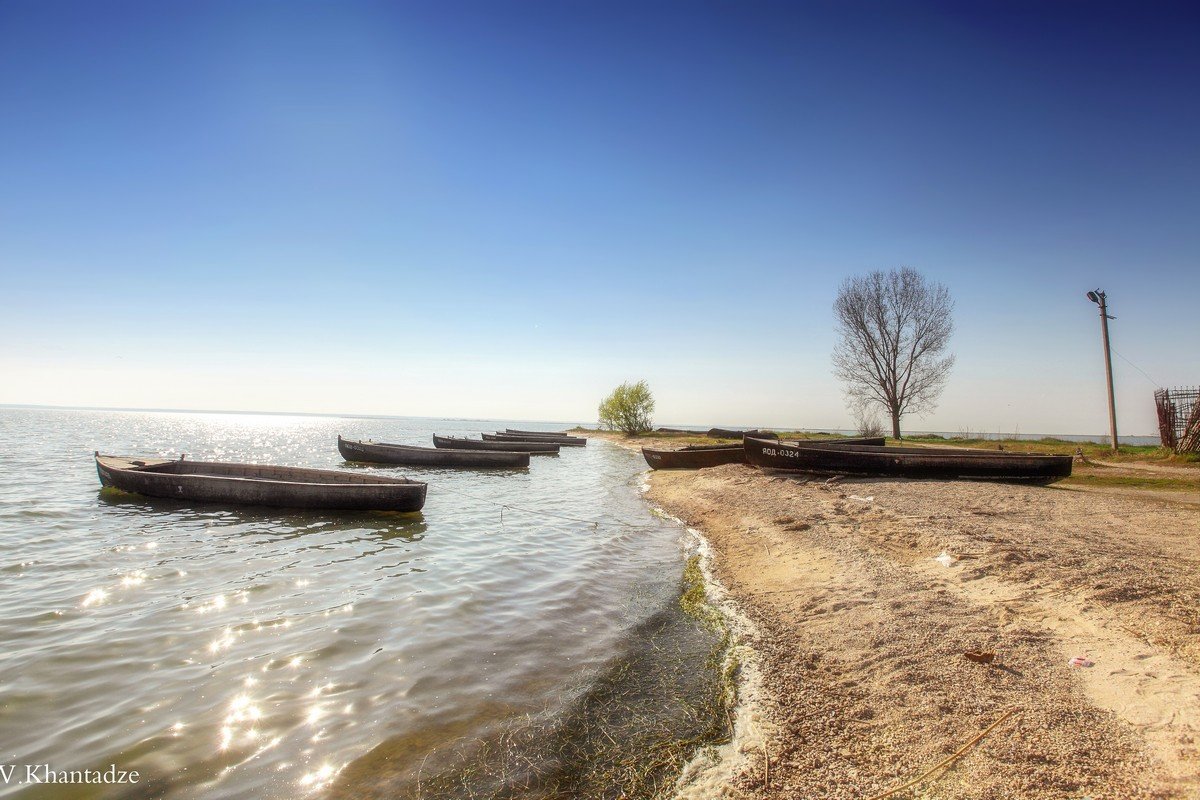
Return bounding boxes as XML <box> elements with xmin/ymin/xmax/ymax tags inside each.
<box><xmin>0</xmin><ymin>409</ymin><xmax>686</xmax><ymax>798</ymax></box>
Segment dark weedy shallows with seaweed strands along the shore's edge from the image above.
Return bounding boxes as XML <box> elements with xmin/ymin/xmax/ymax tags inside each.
<box><xmin>332</xmin><ymin>557</ymin><xmax>736</xmax><ymax>800</ymax></box>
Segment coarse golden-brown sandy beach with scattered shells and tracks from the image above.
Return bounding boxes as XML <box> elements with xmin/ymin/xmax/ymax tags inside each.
<box><xmin>595</xmin><ymin>435</ymin><xmax>1200</xmax><ymax>799</ymax></box>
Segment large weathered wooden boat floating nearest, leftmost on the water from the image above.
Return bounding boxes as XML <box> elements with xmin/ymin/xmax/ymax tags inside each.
<box><xmin>96</xmin><ymin>452</ymin><xmax>427</xmax><ymax>511</ymax></box>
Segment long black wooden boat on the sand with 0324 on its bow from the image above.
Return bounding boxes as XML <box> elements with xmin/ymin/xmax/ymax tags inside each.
<box><xmin>745</xmin><ymin>439</ymin><xmax>1070</xmax><ymax>483</ymax></box>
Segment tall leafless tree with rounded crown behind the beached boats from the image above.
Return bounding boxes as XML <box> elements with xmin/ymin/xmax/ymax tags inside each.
<box><xmin>833</xmin><ymin>266</ymin><xmax>954</xmax><ymax>439</ymax></box>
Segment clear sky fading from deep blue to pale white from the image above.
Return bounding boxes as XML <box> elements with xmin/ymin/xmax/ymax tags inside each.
<box><xmin>0</xmin><ymin>0</ymin><xmax>1200</xmax><ymax>433</ymax></box>
